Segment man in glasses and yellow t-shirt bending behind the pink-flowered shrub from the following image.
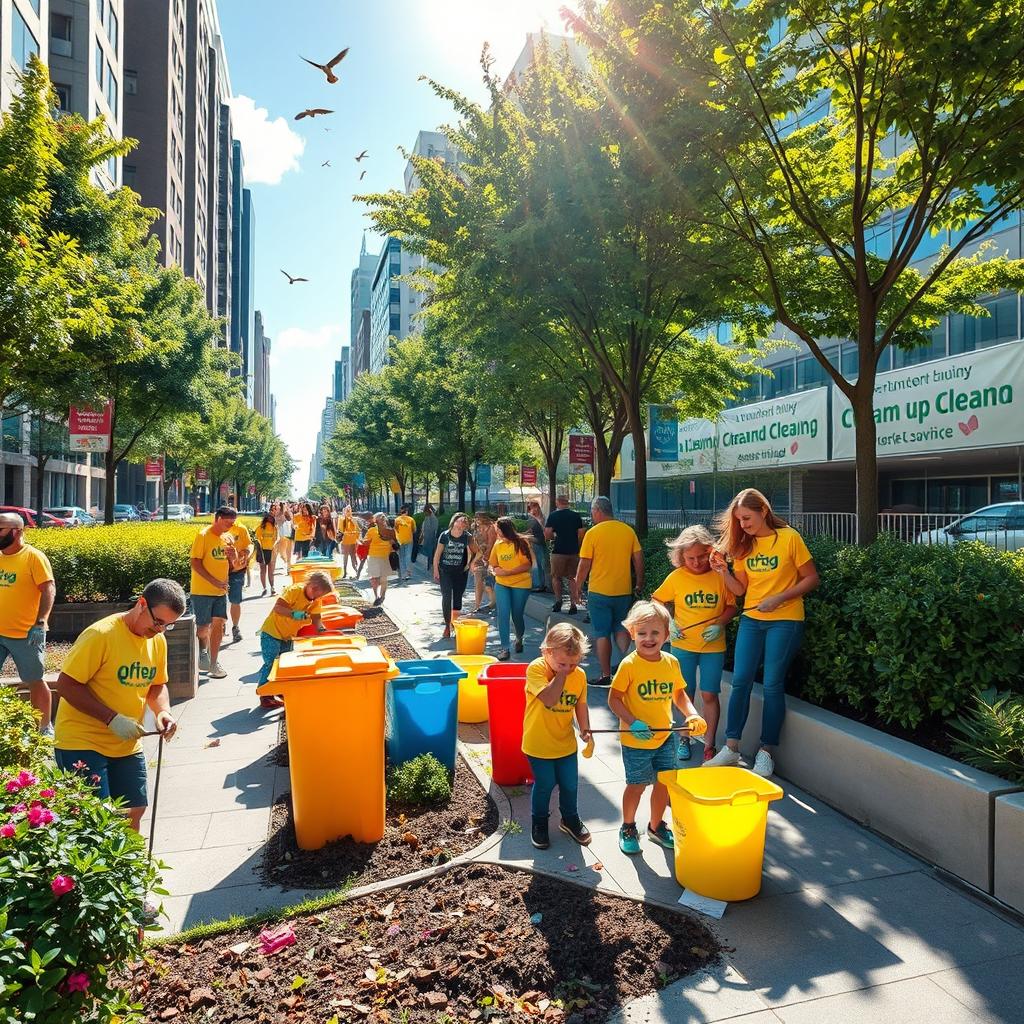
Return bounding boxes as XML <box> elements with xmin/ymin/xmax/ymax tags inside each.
<box><xmin>53</xmin><ymin>580</ymin><xmax>185</xmax><ymax>830</ymax></box>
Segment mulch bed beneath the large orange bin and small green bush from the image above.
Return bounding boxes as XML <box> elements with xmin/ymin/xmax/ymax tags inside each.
<box><xmin>260</xmin><ymin>758</ymin><xmax>499</xmax><ymax>889</ymax></box>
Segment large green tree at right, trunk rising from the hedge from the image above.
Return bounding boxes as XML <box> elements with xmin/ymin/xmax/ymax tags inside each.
<box><xmin>593</xmin><ymin>0</ymin><xmax>1024</xmax><ymax>544</ymax></box>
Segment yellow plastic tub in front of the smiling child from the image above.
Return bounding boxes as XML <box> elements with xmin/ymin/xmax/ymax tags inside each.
<box><xmin>657</xmin><ymin>768</ymin><xmax>782</xmax><ymax>903</ymax></box>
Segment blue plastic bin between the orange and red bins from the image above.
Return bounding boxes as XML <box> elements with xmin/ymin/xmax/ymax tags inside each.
<box><xmin>384</xmin><ymin>658</ymin><xmax>465</xmax><ymax>775</ymax></box>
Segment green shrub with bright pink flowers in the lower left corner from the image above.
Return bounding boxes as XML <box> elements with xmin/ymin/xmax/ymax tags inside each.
<box><xmin>0</xmin><ymin>765</ymin><xmax>165</xmax><ymax>1024</ymax></box>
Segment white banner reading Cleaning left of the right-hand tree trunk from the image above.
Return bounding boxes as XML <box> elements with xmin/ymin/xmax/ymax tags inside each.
<box><xmin>718</xmin><ymin>387</ymin><xmax>828</xmax><ymax>470</ymax></box>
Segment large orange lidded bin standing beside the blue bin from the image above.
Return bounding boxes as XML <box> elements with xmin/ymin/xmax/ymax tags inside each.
<box><xmin>256</xmin><ymin>647</ymin><xmax>398</xmax><ymax>850</ymax></box>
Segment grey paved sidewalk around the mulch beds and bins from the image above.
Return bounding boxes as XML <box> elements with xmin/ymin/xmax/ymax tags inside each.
<box><xmin>143</xmin><ymin>570</ymin><xmax>1024</xmax><ymax>1024</ymax></box>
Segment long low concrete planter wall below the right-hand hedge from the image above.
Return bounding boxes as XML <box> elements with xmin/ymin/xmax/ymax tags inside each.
<box><xmin>720</xmin><ymin>686</ymin><xmax>1024</xmax><ymax>905</ymax></box>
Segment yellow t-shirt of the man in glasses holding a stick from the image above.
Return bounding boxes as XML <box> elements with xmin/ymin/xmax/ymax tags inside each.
<box><xmin>53</xmin><ymin>613</ymin><xmax>167</xmax><ymax>758</ymax></box>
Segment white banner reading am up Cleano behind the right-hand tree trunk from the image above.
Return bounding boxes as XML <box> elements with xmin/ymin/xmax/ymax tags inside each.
<box><xmin>833</xmin><ymin>341</ymin><xmax>1024</xmax><ymax>459</ymax></box>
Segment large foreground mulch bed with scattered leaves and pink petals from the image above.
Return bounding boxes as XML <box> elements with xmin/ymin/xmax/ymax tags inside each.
<box><xmin>130</xmin><ymin>864</ymin><xmax>720</xmax><ymax>1024</ymax></box>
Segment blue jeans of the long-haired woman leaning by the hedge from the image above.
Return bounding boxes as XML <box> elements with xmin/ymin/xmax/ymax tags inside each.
<box><xmin>725</xmin><ymin>615</ymin><xmax>804</xmax><ymax>746</ymax></box>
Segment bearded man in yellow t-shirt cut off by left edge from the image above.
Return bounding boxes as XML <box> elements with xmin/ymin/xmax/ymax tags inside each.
<box><xmin>0</xmin><ymin>512</ymin><xmax>56</xmax><ymax>736</ymax></box>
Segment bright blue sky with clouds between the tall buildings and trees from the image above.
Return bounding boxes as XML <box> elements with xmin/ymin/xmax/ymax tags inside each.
<box><xmin>219</xmin><ymin>0</ymin><xmax>572</xmax><ymax>494</ymax></box>
